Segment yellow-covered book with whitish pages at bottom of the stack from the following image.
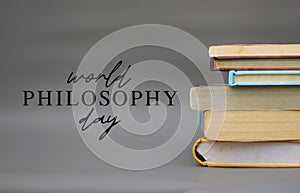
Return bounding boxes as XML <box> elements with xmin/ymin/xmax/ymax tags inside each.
<box><xmin>192</xmin><ymin>138</ymin><xmax>300</xmax><ymax>168</ymax></box>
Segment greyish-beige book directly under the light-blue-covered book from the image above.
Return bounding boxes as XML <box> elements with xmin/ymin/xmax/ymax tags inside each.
<box><xmin>190</xmin><ymin>86</ymin><xmax>300</xmax><ymax>111</ymax></box>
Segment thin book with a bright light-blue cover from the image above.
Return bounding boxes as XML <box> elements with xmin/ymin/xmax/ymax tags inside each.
<box><xmin>228</xmin><ymin>70</ymin><xmax>300</xmax><ymax>86</ymax></box>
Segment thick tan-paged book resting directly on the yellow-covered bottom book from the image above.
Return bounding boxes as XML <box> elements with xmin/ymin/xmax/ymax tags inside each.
<box><xmin>203</xmin><ymin>110</ymin><xmax>300</xmax><ymax>142</ymax></box>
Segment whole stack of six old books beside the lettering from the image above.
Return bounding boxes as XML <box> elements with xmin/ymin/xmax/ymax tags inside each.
<box><xmin>190</xmin><ymin>44</ymin><xmax>300</xmax><ymax>167</ymax></box>
